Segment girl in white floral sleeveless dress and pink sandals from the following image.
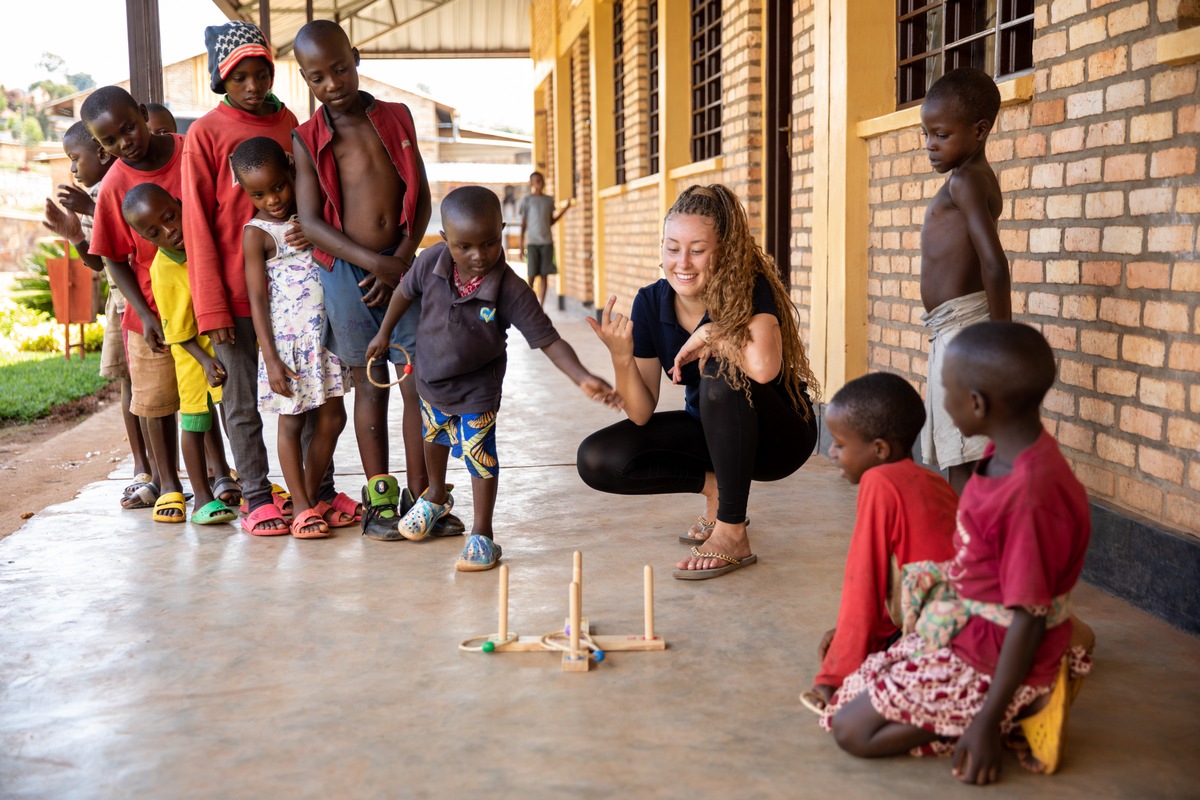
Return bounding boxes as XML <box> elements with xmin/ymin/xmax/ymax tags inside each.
<box><xmin>230</xmin><ymin>137</ymin><xmax>354</xmax><ymax>539</ymax></box>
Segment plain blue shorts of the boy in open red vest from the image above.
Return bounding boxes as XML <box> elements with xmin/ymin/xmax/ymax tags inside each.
<box><xmin>318</xmin><ymin>248</ymin><xmax>421</xmax><ymax>367</ymax></box>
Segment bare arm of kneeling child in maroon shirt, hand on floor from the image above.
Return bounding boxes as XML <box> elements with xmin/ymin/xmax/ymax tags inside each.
<box><xmin>953</xmin><ymin>608</ymin><xmax>1046</xmax><ymax>786</ymax></box>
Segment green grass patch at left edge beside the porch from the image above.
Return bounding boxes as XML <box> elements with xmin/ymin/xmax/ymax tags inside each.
<box><xmin>0</xmin><ymin>353</ymin><xmax>109</xmax><ymax>423</ymax></box>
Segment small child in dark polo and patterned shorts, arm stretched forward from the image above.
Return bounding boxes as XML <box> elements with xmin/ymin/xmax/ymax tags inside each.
<box><xmin>367</xmin><ymin>186</ymin><xmax>619</xmax><ymax>572</ymax></box>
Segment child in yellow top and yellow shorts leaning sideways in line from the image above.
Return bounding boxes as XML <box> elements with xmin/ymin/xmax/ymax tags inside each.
<box><xmin>121</xmin><ymin>184</ymin><xmax>238</xmax><ymax>525</ymax></box>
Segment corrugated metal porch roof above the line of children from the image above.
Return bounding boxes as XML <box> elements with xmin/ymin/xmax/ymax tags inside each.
<box><xmin>214</xmin><ymin>0</ymin><xmax>529</xmax><ymax>59</ymax></box>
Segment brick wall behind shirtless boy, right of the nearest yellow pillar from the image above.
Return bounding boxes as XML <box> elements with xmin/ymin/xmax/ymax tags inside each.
<box><xmin>868</xmin><ymin>0</ymin><xmax>1200</xmax><ymax>534</ymax></box>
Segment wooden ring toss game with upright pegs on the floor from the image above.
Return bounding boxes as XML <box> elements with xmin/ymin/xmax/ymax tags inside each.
<box><xmin>458</xmin><ymin>551</ymin><xmax>667</xmax><ymax>672</ymax></box>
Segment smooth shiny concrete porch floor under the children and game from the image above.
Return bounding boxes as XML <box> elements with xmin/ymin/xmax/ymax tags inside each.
<box><xmin>0</xmin><ymin>302</ymin><xmax>1200</xmax><ymax>798</ymax></box>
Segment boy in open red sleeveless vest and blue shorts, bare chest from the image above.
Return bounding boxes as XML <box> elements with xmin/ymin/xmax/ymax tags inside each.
<box><xmin>293</xmin><ymin>19</ymin><xmax>462</xmax><ymax>541</ymax></box>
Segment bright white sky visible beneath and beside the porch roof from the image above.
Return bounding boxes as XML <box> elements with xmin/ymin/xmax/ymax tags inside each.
<box><xmin>0</xmin><ymin>0</ymin><xmax>533</xmax><ymax>131</ymax></box>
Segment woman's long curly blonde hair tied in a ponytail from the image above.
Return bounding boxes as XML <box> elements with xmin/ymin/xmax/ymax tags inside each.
<box><xmin>666</xmin><ymin>184</ymin><xmax>821</xmax><ymax>420</ymax></box>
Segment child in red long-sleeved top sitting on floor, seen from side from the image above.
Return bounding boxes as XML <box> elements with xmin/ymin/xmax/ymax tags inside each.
<box><xmin>800</xmin><ymin>372</ymin><xmax>959</xmax><ymax>711</ymax></box>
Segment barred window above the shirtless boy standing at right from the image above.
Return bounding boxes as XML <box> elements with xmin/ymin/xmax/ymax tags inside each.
<box><xmin>896</xmin><ymin>0</ymin><xmax>1033</xmax><ymax>108</ymax></box>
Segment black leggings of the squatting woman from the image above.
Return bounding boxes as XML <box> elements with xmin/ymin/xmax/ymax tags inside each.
<box><xmin>576</xmin><ymin>377</ymin><xmax>817</xmax><ymax>523</ymax></box>
